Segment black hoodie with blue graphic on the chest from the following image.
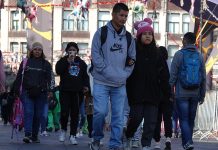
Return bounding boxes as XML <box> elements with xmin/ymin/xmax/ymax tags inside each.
<box><xmin>55</xmin><ymin>56</ymin><xmax>89</xmax><ymax>92</ymax></box>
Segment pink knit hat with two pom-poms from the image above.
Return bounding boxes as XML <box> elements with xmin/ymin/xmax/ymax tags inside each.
<box><xmin>134</xmin><ymin>18</ymin><xmax>154</xmax><ymax>37</ymax></box>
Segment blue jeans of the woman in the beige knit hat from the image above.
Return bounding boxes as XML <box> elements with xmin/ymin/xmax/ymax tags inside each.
<box><xmin>21</xmin><ymin>91</ymin><xmax>47</xmax><ymax>136</ymax></box>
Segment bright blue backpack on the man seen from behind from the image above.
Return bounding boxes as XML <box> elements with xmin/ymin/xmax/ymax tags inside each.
<box><xmin>179</xmin><ymin>49</ymin><xmax>202</xmax><ymax>90</ymax></box>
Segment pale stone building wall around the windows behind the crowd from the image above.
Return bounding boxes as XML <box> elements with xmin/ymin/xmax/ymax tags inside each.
<box><xmin>0</xmin><ymin>0</ymin><xmax>192</xmax><ymax>65</ymax></box>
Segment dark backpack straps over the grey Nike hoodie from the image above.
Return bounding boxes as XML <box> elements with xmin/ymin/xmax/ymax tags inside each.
<box><xmin>89</xmin><ymin>25</ymin><xmax>132</xmax><ymax>72</ymax></box>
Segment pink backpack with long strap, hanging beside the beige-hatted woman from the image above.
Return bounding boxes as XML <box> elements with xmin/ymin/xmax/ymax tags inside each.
<box><xmin>10</xmin><ymin>58</ymin><xmax>27</xmax><ymax>139</ymax></box>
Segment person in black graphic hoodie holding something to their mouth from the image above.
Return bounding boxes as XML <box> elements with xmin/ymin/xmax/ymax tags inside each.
<box><xmin>56</xmin><ymin>42</ymin><xmax>89</xmax><ymax>145</ymax></box>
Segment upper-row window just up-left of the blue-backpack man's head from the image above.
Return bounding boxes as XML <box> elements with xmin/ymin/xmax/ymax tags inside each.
<box><xmin>168</xmin><ymin>14</ymin><xmax>180</xmax><ymax>34</ymax></box>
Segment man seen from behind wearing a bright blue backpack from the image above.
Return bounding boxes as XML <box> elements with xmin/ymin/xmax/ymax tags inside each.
<box><xmin>170</xmin><ymin>32</ymin><xmax>206</xmax><ymax>150</ymax></box>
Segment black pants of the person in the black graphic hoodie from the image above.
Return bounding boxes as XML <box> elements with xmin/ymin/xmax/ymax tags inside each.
<box><xmin>60</xmin><ymin>91</ymin><xmax>83</xmax><ymax>136</ymax></box>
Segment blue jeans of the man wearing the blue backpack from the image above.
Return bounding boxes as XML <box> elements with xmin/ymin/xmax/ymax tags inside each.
<box><xmin>176</xmin><ymin>97</ymin><xmax>198</xmax><ymax>147</ymax></box>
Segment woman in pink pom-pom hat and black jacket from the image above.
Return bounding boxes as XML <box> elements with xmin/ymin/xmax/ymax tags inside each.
<box><xmin>124</xmin><ymin>18</ymin><xmax>170</xmax><ymax>150</ymax></box>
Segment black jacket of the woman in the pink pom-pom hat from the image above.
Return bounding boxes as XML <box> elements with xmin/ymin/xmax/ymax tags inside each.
<box><xmin>126</xmin><ymin>43</ymin><xmax>170</xmax><ymax>105</ymax></box>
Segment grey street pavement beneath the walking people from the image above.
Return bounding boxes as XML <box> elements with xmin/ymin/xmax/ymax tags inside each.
<box><xmin>0</xmin><ymin>121</ymin><xmax>218</xmax><ymax>150</ymax></box>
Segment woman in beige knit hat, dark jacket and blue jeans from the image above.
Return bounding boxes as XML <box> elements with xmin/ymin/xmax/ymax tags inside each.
<box><xmin>15</xmin><ymin>42</ymin><xmax>54</xmax><ymax>143</ymax></box>
